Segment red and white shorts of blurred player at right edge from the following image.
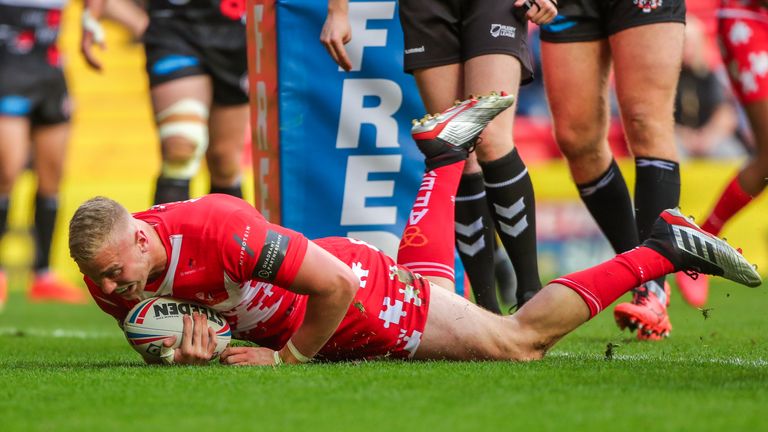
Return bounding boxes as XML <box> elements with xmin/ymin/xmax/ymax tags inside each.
<box><xmin>718</xmin><ymin>2</ymin><xmax>768</xmax><ymax>104</ymax></box>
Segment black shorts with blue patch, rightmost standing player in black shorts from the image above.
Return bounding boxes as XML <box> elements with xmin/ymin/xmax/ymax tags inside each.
<box><xmin>541</xmin><ymin>0</ymin><xmax>685</xmax><ymax>43</ymax></box>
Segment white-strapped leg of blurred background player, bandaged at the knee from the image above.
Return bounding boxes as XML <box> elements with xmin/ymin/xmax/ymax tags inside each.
<box><xmin>150</xmin><ymin>75</ymin><xmax>212</xmax><ymax>204</ymax></box>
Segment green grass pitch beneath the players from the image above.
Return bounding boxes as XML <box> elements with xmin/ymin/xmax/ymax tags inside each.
<box><xmin>0</xmin><ymin>281</ymin><xmax>768</xmax><ymax>432</ymax></box>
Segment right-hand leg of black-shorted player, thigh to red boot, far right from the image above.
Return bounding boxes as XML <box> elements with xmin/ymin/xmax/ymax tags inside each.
<box><xmin>610</xmin><ymin>22</ymin><xmax>685</xmax><ymax>339</ymax></box>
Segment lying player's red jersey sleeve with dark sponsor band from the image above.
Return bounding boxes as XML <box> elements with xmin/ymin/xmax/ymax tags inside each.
<box><xmin>221</xmin><ymin>208</ymin><xmax>309</xmax><ymax>288</ymax></box>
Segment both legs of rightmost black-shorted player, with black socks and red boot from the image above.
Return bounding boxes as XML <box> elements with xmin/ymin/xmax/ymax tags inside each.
<box><xmin>542</xmin><ymin>2</ymin><xmax>684</xmax><ymax>338</ymax></box>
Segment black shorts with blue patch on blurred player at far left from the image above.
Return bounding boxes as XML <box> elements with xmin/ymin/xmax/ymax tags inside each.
<box><xmin>0</xmin><ymin>56</ymin><xmax>72</xmax><ymax>126</ymax></box>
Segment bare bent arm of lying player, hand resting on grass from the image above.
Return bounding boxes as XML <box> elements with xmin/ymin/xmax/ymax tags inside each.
<box><xmin>221</xmin><ymin>242</ymin><xmax>360</xmax><ymax>365</ymax></box>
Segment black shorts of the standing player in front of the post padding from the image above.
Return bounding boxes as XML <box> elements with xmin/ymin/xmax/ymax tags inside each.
<box><xmin>399</xmin><ymin>0</ymin><xmax>533</xmax><ymax>83</ymax></box>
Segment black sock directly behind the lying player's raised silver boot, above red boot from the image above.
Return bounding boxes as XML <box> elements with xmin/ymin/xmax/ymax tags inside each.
<box><xmin>635</xmin><ymin>158</ymin><xmax>680</xmax><ymax>289</ymax></box>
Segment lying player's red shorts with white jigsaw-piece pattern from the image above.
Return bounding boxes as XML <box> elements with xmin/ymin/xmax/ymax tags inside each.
<box><xmin>317</xmin><ymin>263</ymin><xmax>430</xmax><ymax>361</ymax></box>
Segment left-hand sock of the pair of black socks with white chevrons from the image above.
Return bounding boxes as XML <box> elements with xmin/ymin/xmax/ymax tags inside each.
<box><xmin>455</xmin><ymin>173</ymin><xmax>501</xmax><ymax>314</ymax></box>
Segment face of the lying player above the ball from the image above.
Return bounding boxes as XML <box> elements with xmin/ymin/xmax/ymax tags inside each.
<box><xmin>81</xmin><ymin>231</ymin><xmax>150</xmax><ymax>300</ymax></box>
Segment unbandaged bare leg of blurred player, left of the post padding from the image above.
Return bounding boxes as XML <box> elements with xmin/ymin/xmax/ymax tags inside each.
<box><xmin>205</xmin><ymin>105</ymin><xmax>249</xmax><ymax>198</ymax></box>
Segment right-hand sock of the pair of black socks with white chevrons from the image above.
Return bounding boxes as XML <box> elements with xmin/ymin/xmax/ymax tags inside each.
<box><xmin>480</xmin><ymin>149</ymin><xmax>541</xmax><ymax>307</ymax></box>
